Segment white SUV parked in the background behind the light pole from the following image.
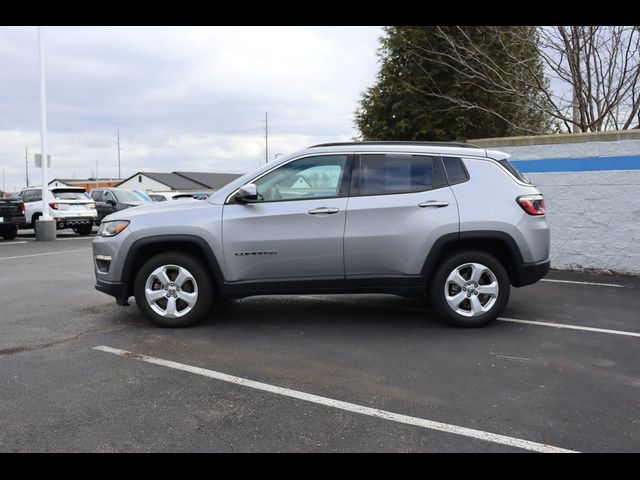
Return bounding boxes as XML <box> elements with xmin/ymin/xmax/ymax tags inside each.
<box><xmin>12</xmin><ymin>187</ymin><xmax>98</xmax><ymax>235</ymax></box>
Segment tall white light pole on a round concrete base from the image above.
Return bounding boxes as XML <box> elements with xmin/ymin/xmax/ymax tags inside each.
<box><xmin>34</xmin><ymin>27</ymin><xmax>56</xmax><ymax>241</ymax></box>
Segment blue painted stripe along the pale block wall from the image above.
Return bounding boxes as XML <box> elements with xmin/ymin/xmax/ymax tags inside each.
<box><xmin>511</xmin><ymin>155</ymin><xmax>640</xmax><ymax>173</ymax></box>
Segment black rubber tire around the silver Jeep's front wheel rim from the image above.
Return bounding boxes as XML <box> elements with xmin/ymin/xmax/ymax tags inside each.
<box><xmin>134</xmin><ymin>252</ymin><xmax>215</xmax><ymax>328</ymax></box>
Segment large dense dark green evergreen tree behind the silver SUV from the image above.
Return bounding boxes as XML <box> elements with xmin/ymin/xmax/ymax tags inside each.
<box><xmin>355</xmin><ymin>26</ymin><xmax>554</xmax><ymax>141</ymax></box>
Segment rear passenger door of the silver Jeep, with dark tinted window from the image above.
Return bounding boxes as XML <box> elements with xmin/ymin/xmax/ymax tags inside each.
<box><xmin>344</xmin><ymin>153</ymin><xmax>459</xmax><ymax>280</ymax></box>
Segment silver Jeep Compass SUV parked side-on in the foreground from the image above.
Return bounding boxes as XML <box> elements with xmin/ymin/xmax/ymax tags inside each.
<box><xmin>93</xmin><ymin>142</ymin><xmax>549</xmax><ymax>327</ymax></box>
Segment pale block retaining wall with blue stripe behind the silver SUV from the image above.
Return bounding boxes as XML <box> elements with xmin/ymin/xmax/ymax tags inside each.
<box><xmin>469</xmin><ymin>130</ymin><xmax>640</xmax><ymax>275</ymax></box>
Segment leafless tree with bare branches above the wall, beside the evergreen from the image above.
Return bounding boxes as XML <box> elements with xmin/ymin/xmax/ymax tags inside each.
<box><xmin>398</xmin><ymin>26</ymin><xmax>640</xmax><ymax>133</ymax></box>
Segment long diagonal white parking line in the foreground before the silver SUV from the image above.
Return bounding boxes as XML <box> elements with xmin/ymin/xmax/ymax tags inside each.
<box><xmin>93</xmin><ymin>345</ymin><xmax>576</xmax><ymax>453</ymax></box>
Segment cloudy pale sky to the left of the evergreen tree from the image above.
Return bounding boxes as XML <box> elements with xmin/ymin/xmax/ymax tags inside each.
<box><xmin>0</xmin><ymin>27</ymin><xmax>382</xmax><ymax>191</ymax></box>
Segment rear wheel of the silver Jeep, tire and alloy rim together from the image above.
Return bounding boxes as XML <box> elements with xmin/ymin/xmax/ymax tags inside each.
<box><xmin>430</xmin><ymin>251</ymin><xmax>510</xmax><ymax>327</ymax></box>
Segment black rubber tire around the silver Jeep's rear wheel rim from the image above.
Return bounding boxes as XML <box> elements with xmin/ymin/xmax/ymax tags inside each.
<box><xmin>429</xmin><ymin>250</ymin><xmax>511</xmax><ymax>328</ymax></box>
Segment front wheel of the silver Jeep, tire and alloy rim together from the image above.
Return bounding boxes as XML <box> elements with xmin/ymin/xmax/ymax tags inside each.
<box><xmin>134</xmin><ymin>253</ymin><xmax>214</xmax><ymax>328</ymax></box>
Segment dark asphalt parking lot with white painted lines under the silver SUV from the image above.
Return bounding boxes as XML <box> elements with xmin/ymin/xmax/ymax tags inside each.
<box><xmin>0</xmin><ymin>231</ymin><xmax>640</xmax><ymax>452</ymax></box>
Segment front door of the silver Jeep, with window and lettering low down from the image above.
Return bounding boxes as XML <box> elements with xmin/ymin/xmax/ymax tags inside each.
<box><xmin>222</xmin><ymin>154</ymin><xmax>350</xmax><ymax>282</ymax></box>
